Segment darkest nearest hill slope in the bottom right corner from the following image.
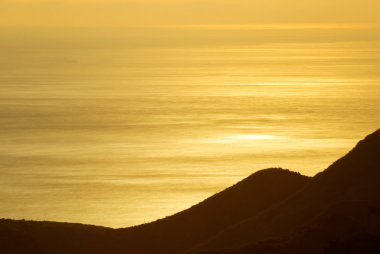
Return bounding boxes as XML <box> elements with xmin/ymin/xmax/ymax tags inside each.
<box><xmin>201</xmin><ymin>201</ymin><xmax>380</xmax><ymax>254</ymax></box>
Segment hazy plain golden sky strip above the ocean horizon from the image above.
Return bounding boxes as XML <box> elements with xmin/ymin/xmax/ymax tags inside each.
<box><xmin>0</xmin><ymin>0</ymin><xmax>380</xmax><ymax>27</ymax></box>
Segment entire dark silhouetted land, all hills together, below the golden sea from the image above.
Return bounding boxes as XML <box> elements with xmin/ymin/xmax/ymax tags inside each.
<box><xmin>0</xmin><ymin>130</ymin><xmax>380</xmax><ymax>254</ymax></box>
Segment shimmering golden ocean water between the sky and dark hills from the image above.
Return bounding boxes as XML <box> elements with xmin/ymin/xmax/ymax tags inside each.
<box><xmin>0</xmin><ymin>27</ymin><xmax>380</xmax><ymax>227</ymax></box>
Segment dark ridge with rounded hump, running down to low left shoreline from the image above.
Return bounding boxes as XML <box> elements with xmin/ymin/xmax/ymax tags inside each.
<box><xmin>0</xmin><ymin>168</ymin><xmax>310</xmax><ymax>254</ymax></box>
